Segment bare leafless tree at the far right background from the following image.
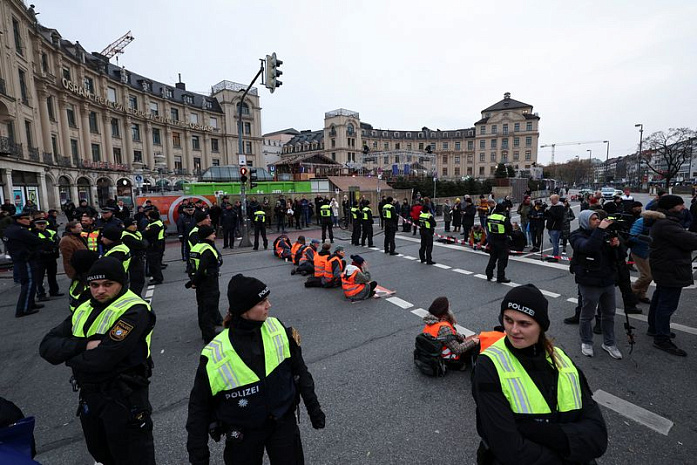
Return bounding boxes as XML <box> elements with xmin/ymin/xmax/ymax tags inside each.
<box><xmin>640</xmin><ymin>128</ymin><xmax>697</xmax><ymax>188</ymax></box>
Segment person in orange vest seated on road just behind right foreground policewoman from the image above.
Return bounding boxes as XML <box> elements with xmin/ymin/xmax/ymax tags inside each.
<box><xmin>423</xmin><ymin>297</ymin><xmax>479</xmax><ymax>370</ymax></box>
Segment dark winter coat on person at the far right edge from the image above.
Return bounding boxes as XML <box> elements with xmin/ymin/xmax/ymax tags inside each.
<box><xmin>649</xmin><ymin>209</ymin><xmax>697</xmax><ymax>287</ymax></box>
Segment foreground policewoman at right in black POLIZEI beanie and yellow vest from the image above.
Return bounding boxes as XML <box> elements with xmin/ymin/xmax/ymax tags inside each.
<box><xmin>472</xmin><ymin>284</ymin><xmax>607</xmax><ymax>465</ymax></box>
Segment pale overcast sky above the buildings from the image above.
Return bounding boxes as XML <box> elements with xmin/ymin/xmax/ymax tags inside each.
<box><xmin>34</xmin><ymin>0</ymin><xmax>697</xmax><ymax>163</ymax></box>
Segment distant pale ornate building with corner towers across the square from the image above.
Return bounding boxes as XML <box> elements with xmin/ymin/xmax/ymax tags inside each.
<box><xmin>283</xmin><ymin>93</ymin><xmax>540</xmax><ymax>179</ymax></box>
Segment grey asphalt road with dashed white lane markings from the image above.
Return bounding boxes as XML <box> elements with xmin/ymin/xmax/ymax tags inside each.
<box><xmin>0</xmin><ymin>190</ymin><xmax>697</xmax><ymax>465</ymax></box>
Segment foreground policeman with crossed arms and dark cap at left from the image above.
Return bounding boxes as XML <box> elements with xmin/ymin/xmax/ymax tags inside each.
<box><xmin>39</xmin><ymin>257</ymin><xmax>155</xmax><ymax>465</ymax></box>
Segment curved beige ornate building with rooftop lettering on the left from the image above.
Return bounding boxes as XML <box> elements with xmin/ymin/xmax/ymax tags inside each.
<box><xmin>0</xmin><ymin>0</ymin><xmax>263</xmax><ymax>209</ymax></box>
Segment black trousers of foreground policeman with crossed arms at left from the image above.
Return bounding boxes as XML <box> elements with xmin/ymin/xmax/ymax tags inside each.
<box><xmin>78</xmin><ymin>386</ymin><xmax>155</xmax><ymax>465</ymax></box>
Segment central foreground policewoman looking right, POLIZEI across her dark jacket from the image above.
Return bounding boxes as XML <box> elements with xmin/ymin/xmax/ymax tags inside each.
<box><xmin>186</xmin><ymin>274</ymin><xmax>325</xmax><ymax>465</ymax></box>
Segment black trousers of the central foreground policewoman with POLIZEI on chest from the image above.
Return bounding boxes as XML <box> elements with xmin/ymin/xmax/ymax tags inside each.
<box><xmin>223</xmin><ymin>409</ymin><xmax>305</xmax><ymax>465</ymax></box>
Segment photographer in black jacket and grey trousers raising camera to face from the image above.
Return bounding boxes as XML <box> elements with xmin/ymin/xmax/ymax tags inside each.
<box><xmin>569</xmin><ymin>210</ymin><xmax>622</xmax><ymax>360</ymax></box>
